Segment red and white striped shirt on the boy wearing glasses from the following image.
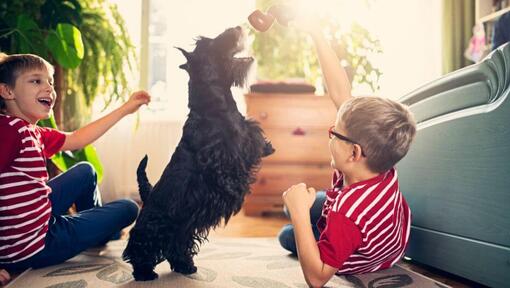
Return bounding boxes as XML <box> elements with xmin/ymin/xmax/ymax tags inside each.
<box><xmin>317</xmin><ymin>168</ymin><xmax>411</xmax><ymax>274</ymax></box>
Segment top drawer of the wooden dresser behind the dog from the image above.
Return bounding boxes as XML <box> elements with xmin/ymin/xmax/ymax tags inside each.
<box><xmin>245</xmin><ymin>93</ymin><xmax>336</xmax><ymax>129</ymax></box>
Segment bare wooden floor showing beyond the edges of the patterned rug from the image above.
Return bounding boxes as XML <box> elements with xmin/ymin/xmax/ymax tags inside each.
<box><xmin>210</xmin><ymin>211</ymin><xmax>486</xmax><ymax>288</ymax></box>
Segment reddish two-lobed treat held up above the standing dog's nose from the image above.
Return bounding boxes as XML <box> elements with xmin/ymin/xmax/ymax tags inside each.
<box><xmin>248</xmin><ymin>4</ymin><xmax>296</xmax><ymax>32</ymax></box>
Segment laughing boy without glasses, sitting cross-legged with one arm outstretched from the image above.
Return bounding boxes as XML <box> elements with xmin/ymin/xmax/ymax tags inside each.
<box><xmin>0</xmin><ymin>53</ymin><xmax>150</xmax><ymax>282</ymax></box>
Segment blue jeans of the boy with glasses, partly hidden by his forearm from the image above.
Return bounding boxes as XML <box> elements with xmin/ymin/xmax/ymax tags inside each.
<box><xmin>278</xmin><ymin>191</ymin><xmax>326</xmax><ymax>255</ymax></box>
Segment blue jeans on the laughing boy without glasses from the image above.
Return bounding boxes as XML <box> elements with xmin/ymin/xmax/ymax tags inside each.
<box><xmin>2</xmin><ymin>162</ymin><xmax>138</xmax><ymax>270</ymax></box>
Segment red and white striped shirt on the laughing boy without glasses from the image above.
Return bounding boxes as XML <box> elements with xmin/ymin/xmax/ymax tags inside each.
<box><xmin>0</xmin><ymin>114</ymin><xmax>65</xmax><ymax>263</ymax></box>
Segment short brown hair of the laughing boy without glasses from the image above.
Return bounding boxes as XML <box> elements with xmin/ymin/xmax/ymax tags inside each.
<box><xmin>0</xmin><ymin>52</ymin><xmax>54</xmax><ymax>112</ymax></box>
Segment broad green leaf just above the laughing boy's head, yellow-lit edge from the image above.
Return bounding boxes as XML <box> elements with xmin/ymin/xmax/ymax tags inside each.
<box><xmin>46</xmin><ymin>23</ymin><xmax>84</xmax><ymax>69</ymax></box>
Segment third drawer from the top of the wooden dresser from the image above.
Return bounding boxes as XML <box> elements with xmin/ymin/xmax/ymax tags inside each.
<box><xmin>251</xmin><ymin>164</ymin><xmax>333</xmax><ymax>196</ymax></box>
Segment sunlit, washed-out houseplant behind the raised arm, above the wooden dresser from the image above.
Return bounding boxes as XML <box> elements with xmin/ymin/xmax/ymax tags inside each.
<box><xmin>251</xmin><ymin>0</ymin><xmax>382</xmax><ymax>91</ymax></box>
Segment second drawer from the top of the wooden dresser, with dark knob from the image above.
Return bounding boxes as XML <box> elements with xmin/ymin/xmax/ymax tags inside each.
<box><xmin>262</xmin><ymin>127</ymin><xmax>331</xmax><ymax>165</ymax></box>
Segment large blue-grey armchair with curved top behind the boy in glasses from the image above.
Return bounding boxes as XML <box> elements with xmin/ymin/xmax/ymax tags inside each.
<box><xmin>397</xmin><ymin>43</ymin><xmax>510</xmax><ymax>287</ymax></box>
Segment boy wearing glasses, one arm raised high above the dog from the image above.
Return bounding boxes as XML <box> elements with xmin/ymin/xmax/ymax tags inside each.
<box><xmin>279</xmin><ymin>12</ymin><xmax>416</xmax><ymax>287</ymax></box>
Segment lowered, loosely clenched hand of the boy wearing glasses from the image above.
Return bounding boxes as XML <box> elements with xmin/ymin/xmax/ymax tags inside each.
<box><xmin>282</xmin><ymin>183</ymin><xmax>315</xmax><ymax>216</ymax></box>
